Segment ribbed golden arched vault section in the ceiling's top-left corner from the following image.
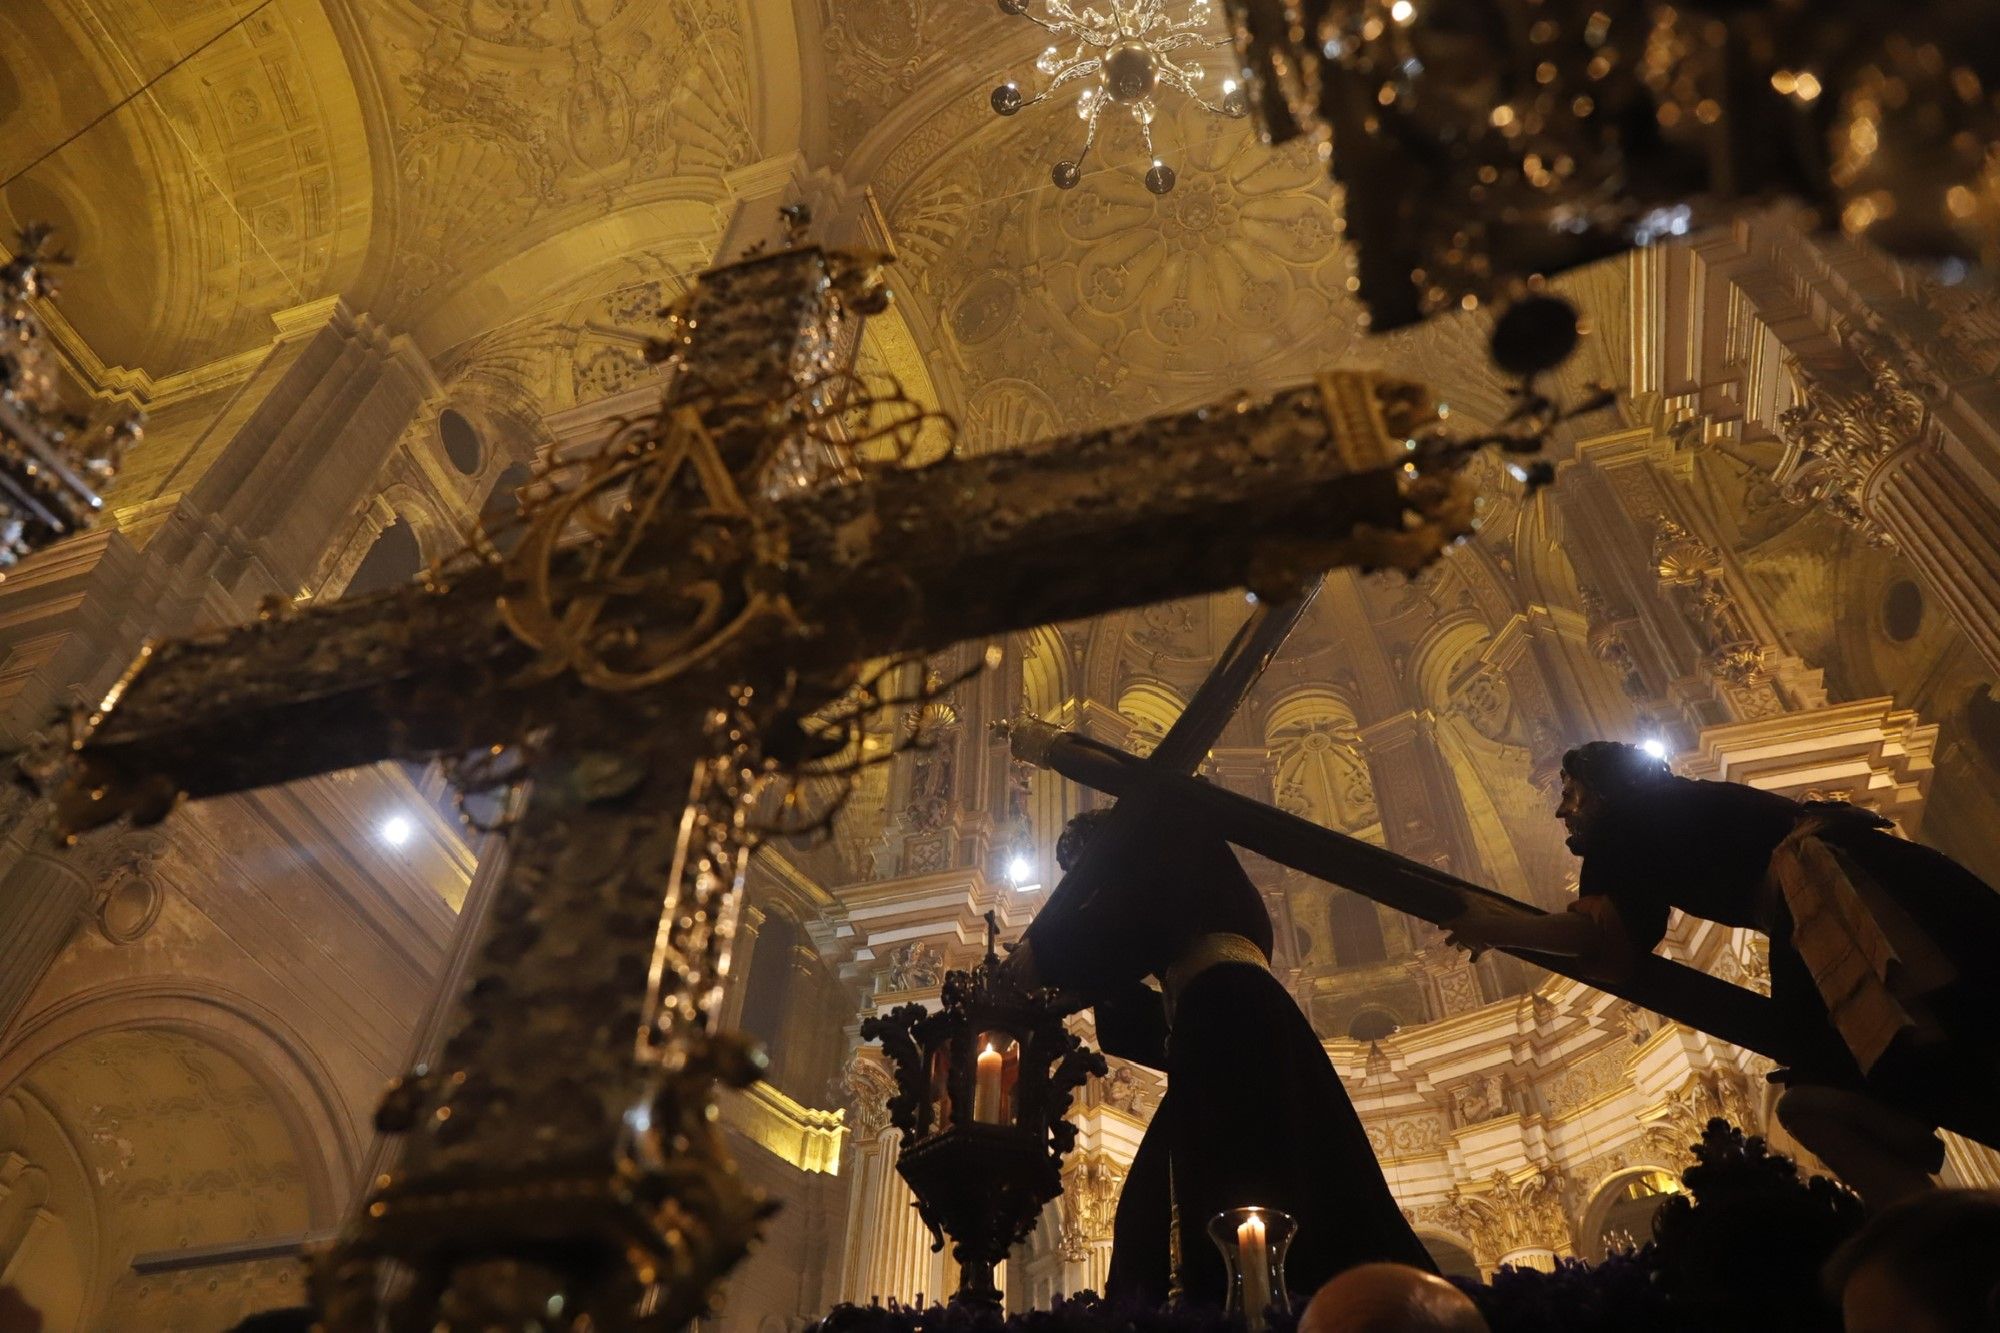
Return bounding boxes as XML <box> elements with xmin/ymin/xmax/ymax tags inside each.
<box><xmin>0</xmin><ymin>0</ymin><xmax>376</xmax><ymax>378</ymax></box>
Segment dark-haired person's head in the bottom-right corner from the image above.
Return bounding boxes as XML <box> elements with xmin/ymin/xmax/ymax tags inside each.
<box><xmin>1826</xmin><ymin>1189</ymin><xmax>2000</xmax><ymax>1333</ymax></box>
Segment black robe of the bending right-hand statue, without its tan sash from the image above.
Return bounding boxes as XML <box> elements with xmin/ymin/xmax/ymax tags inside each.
<box><xmin>1578</xmin><ymin>779</ymin><xmax>2000</xmax><ymax>1137</ymax></box>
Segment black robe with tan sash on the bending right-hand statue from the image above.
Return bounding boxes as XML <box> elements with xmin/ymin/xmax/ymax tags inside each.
<box><xmin>1576</xmin><ymin>777</ymin><xmax>2000</xmax><ymax>1127</ymax></box>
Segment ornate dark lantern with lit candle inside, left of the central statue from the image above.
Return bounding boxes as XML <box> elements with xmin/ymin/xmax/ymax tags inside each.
<box><xmin>862</xmin><ymin>913</ymin><xmax>1106</xmax><ymax>1307</ymax></box>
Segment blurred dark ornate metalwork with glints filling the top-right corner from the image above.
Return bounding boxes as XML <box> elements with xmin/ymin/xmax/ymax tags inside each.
<box><xmin>1224</xmin><ymin>0</ymin><xmax>2000</xmax><ymax>364</ymax></box>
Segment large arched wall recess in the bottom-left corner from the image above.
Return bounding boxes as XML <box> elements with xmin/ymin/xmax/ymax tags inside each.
<box><xmin>0</xmin><ymin>1025</ymin><xmax>332</xmax><ymax>1329</ymax></box>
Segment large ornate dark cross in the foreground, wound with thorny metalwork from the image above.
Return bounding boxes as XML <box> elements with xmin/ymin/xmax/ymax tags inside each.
<box><xmin>19</xmin><ymin>248</ymin><xmax>1472</xmax><ymax>1329</ymax></box>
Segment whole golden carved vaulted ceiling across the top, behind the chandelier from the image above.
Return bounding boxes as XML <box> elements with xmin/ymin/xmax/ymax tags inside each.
<box><xmin>0</xmin><ymin>0</ymin><xmax>1640</xmax><ymax>434</ymax></box>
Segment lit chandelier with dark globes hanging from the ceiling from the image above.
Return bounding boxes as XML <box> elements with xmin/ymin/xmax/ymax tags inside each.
<box><xmin>992</xmin><ymin>0</ymin><xmax>1250</xmax><ymax>194</ymax></box>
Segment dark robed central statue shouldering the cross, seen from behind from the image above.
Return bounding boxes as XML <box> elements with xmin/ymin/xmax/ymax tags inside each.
<box><xmin>1026</xmin><ymin>821</ymin><xmax>1434</xmax><ymax>1305</ymax></box>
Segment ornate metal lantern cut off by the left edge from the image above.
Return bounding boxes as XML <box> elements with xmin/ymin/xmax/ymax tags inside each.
<box><xmin>0</xmin><ymin>226</ymin><xmax>142</xmax><ymax>570</ymax></box>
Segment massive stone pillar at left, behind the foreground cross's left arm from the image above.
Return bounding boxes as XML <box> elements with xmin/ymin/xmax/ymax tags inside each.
<box><xmin>0</xmin><ymin>298</ymin><xmax>438</xmax><ymax>1025</ymax></box>
